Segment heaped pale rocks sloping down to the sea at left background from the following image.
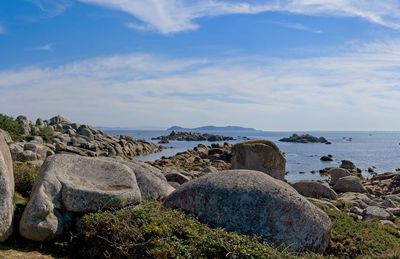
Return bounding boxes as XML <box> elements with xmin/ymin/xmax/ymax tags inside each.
<box><xmin>6</xmin><ymin>116</ymin><xmax>161</xmax><ymax>166</ymax></box>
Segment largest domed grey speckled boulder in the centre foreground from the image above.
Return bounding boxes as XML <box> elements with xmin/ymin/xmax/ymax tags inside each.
<box><xmin>164</xmin><ymin>170</ymin><xmax>332</xmax><ymax>252</ymax></box>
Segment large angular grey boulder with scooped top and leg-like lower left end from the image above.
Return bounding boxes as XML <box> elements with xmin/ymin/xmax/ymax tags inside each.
<box><xmin>20</xmin><ymin>155</ymin><xmax>141</xmax><ymax>241</ymax></box>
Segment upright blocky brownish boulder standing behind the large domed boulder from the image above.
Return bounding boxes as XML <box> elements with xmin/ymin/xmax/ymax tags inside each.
<box><xmin>232</xmin><ymin>140</ymin><xmax>286</xmax><ymax>180</ymax></box>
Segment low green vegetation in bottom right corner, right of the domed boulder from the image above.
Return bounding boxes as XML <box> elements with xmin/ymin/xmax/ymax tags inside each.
<box><xmin>324</xmin><ymin>209</ymin><xmax>400</xmax><ymax>258</ymax></box>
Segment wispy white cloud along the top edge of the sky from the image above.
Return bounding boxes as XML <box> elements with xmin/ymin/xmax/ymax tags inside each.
<box><xmin>78</xmin><ymin>0</ymin><xmax>400</xmax><ymax>34</ymax></box>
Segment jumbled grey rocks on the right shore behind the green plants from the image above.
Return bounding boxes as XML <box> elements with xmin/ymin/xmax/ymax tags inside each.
<box><xmin>292</xmin><ymin>164</ymin><xmax>400</xmax><ymax>228</ymax></box>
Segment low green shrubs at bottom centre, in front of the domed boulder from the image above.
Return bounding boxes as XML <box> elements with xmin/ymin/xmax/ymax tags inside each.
<box><xmin>73</xmin><ymin>202</ymin><xmax>291</xmax><ymax>258</ymax></box>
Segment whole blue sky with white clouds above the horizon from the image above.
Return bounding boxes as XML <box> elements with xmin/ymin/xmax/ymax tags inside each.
<box><xmin>0</xmin><ymin>0</ymin><xmax>400</xmax><ymax>131</ymax></box>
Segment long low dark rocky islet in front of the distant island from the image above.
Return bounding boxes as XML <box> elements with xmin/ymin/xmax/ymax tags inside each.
<box><xmin>152</xmin><ymin>131</ymin><xmax>234</xmax><ymax>144</ymax></box>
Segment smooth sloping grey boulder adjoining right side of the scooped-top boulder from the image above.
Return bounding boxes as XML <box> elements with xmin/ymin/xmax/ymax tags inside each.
<box><xmin>121</xmin><ymin>160</ymin><xmax>175</xmax><ymax>200</ymax></box>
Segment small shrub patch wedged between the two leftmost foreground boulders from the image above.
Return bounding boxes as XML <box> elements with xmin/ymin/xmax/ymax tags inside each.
<box><xmin>14</xmin><ymin>163</ymin><xmax>39</xmax><ymax>197</ymax></box>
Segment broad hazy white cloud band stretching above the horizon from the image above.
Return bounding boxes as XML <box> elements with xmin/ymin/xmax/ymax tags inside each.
<box><xmin>0</xmin><ymin>40</ymin><xmax>400</xmax><ymax>130</ymax></box>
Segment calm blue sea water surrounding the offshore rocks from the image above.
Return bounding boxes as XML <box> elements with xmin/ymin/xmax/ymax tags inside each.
<box><xmin>107</xmin><ymin>130</ymin><xmax>400</xmax><ymax>182</ymax></box>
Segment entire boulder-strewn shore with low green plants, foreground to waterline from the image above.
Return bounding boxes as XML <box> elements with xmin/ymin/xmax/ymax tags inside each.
<box><xmin>0</xmin><ymin>116</ymin><xmax>400</xmax><ymax>258</ymax></box>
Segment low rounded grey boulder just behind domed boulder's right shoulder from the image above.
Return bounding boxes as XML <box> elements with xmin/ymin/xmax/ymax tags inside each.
<box><xmin>292</xmin><ymin>181</ymin><xmax>337</xmax><ymax>200</ymax></box>
